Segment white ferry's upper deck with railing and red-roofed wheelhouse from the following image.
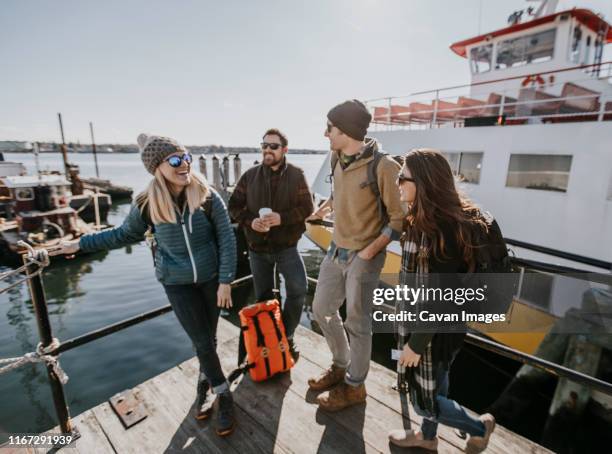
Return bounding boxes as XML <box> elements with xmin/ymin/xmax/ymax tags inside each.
<box><xmin>367</xmin><ymin>2</ymin><xmax>612</xmax><ymax>129</ymax></box>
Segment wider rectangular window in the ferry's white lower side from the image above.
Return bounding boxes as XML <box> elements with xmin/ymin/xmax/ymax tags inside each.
<box><xmin>506</xmin><ymin>154</ymin><xmax>572</xmax><ymax>192</ymax></box>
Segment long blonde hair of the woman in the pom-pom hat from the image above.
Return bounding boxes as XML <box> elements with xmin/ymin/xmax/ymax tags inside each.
<box><xmin>136</xmin><ymin>167</ymin><xmax>210</xmax><ymax>224</ymax></box>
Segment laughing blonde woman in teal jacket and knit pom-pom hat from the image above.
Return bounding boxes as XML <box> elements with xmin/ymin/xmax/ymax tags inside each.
<box><xmin>53</xmin><ymin>134</ymin><xmax>236</xmax><ymax>436</ymax></box>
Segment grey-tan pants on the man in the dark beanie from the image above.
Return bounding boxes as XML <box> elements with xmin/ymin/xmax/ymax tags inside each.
<box><xmin>312</xmin><ymin>250</ymin><xmax>386</xmax><ymax>386</ymax></box>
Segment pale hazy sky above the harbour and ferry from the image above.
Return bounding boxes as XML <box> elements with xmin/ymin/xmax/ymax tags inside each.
<box><xmin>0</xmin><ymin>0</ymin><xmax>612</xmax><ymax>149</ymax></box>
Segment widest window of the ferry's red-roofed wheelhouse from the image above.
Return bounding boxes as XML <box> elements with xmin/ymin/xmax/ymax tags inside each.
<box><xmin>495</xmin><ymin>29</ymin><xmax>556</xmax><ymax>69</ymax></box>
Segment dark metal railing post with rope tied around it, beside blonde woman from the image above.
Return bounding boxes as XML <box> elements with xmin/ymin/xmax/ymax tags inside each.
<box><xmin>23</xmin><ymin>255</ymin><xmax>73</xmax><ymax>433</ymax></box>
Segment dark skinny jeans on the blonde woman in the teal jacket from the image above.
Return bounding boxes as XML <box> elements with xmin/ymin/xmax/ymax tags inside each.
<box><xmin>164</xmin><ymin>279</ymin><xmax>229</xmax><ymax>394</ymax></box>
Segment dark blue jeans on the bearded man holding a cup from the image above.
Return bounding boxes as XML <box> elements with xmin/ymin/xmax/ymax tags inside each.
<box><xmin>249</xmin><ymin>246</ymin><xmax>308</xmax><ymax>338</ymax></box>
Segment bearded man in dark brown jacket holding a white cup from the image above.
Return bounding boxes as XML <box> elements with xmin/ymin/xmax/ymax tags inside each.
<box><xmin>228</xmin><ymin>129</ymin><xmax>313</xmax><ymax>361</ymax></box>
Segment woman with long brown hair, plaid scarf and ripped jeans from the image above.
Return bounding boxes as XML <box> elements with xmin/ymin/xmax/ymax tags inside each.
<box><xmin>389</xmin><ymin>149</ymin><xmax>495</xmax><ymax>453</ymax></box>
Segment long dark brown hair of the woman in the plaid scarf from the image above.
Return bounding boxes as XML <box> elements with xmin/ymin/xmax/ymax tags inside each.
<box><xmin>404</xmin><ymin>149</ymin><xmax>487</xmax><ymax>270</ymax></box>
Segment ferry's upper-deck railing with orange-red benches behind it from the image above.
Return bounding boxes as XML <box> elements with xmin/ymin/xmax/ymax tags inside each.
<box><xmin>366</xmin><ymin>61</ymin><xmax>612</xmax><ymax>131</ymax></box>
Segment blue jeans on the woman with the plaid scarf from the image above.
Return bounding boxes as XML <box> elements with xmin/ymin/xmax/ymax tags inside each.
<box><xmin>414</xmin><ymin>364</ymin><xmax>485</xmax><ymax>440</ymax></box>
